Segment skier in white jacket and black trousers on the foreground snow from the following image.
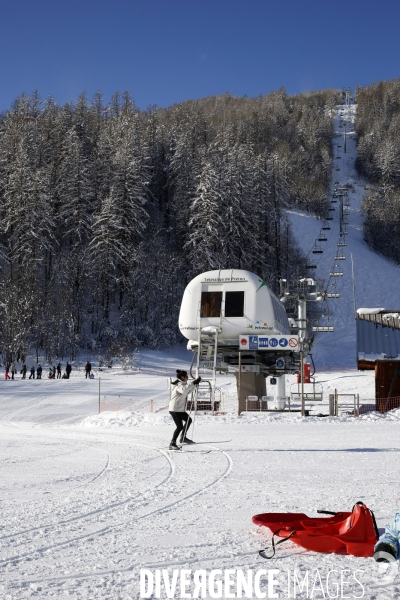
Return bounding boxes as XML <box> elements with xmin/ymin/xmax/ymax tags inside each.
<box><xmin>168</xmin><ymin>369</ymin><xmax>201</xmax><ymax>450</ymax></box>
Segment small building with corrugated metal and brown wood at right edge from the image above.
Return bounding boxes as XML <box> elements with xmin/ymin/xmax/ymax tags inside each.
<box><xmin>356</xmin><ymin>308</ymin><xmax>400</xmax><ymax>413</ymax></box>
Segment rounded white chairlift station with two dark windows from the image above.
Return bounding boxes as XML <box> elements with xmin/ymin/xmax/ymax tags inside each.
<box><xmin>179</xmin><ymin>269</ymin><xmax>299</xmax><ymax>413</ymax></box>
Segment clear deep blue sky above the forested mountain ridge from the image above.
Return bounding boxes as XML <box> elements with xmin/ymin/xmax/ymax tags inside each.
<box><xmin>0</xmin><ymin>0</ymin><xmax>400</xmax><ymax>111</ymax></box>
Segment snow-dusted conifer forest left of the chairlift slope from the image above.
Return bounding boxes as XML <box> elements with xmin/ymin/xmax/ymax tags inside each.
<box><xmin>0</xmin><ymin>89</ymin><xmax>339</xmax><ymax>360</ymax></box>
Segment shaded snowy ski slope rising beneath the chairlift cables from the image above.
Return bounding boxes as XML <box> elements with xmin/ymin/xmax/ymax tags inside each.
<box><xmin>289</xmin><ymin>105</ymin><xmax>400</xmax><ymax>367</ymax></box>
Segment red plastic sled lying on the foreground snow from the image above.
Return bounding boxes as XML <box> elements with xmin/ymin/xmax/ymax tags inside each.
<box><xmin>253</xmin><ymin>502</ymin><xmax>379</xmax><ymax>558</ymax></box>
